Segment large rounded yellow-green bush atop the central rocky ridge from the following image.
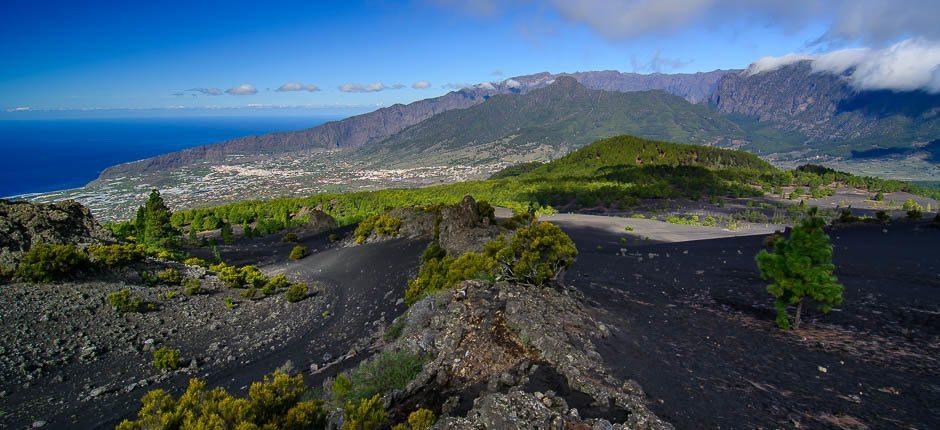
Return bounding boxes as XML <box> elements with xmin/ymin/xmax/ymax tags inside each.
<box><xmin>484</xmin><ymin>222</ymin><xmax>578</xmax><ymax>285</ymax></box>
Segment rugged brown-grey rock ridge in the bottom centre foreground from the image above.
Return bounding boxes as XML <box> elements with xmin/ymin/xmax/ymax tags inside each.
<box><xmin>386</xmin><ymin>281</ymin><xmax>671</xmax><ymax>429</ymax></box>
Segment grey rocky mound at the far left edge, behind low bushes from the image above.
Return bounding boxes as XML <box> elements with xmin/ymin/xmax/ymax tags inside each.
<box><xmin>0</xmin><ymin>200</ymin><xmax>113</xmax><ymax>267</ymax></box>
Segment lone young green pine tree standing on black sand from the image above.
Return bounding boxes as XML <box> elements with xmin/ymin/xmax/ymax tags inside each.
<box><xmin>757</xmin><ymin>211</ymin><xmax>843</xmax><ymax>329</ymax></box>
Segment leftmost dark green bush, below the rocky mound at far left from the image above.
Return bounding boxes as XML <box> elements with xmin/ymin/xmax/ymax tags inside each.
<box><xmin>16</xmin><ymin>243</ymin><xmax>90</xmax><ymax>282</ymax></box>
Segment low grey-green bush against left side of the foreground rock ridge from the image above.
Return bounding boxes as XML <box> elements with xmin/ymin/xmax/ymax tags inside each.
<box><xmin>332</xmin><ymin>351</ymin><xmax>425</xmax><ymax>402</ymax></box>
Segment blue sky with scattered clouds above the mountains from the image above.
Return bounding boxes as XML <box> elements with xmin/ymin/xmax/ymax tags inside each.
<box><xmin>0</xmin><ymin>0</ymin><xmax>940</xmax><ymax>119</ymax></box>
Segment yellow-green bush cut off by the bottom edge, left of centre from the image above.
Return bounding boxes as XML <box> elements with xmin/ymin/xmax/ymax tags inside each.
<box><xmin>117</xmin><ymin>372</ymin><xmax>327</xmax><ymax>430</ymax></box>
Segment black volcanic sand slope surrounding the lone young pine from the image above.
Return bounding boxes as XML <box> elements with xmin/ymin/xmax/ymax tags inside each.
<box><xmin>562</xmin><ymin>223</ymin><xmax>940</xmax><ymax>429</ymax></box>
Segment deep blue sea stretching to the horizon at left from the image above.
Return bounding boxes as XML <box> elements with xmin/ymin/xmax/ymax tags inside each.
<box><xmin>0</xmin><ymin>116</ymin><xmax>338</xmax><ymax>196</ymax></box>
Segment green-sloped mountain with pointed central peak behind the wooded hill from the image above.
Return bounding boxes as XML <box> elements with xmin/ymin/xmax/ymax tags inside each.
<box><xmin>361</xmin><ymin>76</ymin><xmax>745</xmax><ymax>166</ymax></box>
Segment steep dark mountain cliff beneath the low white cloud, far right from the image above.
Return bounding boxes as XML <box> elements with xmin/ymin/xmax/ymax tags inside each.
<box><xmin>709</xmin><ymin>61</ymin><xmax>940</xmax><ymax>156</ymax></box>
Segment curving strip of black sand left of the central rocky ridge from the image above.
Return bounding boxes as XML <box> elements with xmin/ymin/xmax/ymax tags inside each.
<box><xmin>46</xmin><ymin>234</ymin><xmax>427</xmax><ymax>429</ymax></box>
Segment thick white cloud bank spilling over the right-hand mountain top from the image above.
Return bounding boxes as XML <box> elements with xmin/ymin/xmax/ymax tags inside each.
<box><xmin>747</xmin><ymin>38</ymin><xmax>940</xmax><ymax>93</ymax></box>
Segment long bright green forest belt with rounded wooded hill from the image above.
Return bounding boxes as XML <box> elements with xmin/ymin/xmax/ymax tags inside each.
<box><xmin>165</xmin><ymin>136</ymin><xmax>940</xmax><ymax>240</ymax></box>
